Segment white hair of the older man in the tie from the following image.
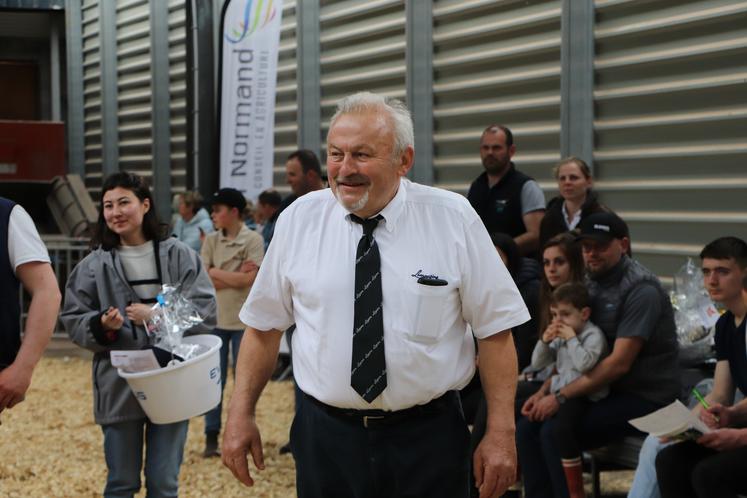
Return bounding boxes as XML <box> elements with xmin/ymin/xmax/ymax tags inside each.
<box><xmin>329</xmin><ymin>92</ymin><xmax>415</xmax><ymax>156</ymax></box>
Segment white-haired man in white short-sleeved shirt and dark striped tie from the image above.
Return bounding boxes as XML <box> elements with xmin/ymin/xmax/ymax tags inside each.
<box><xmin>223</xmin><ymin>93</ymin><xmax>529</xmax><ymax>498</ymax></box>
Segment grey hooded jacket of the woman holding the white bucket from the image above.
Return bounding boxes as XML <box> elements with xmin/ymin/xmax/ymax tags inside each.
<box><xmin>60</xmin><ymin>238</ymin><xmax>216</xmax><ymax>425</ymax></box>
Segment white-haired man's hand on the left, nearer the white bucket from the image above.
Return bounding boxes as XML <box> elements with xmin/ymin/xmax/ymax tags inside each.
<box><xmin>222</xmin><ymin>412</ymin><xmax>265</xmax><ymax>486</ymax></box>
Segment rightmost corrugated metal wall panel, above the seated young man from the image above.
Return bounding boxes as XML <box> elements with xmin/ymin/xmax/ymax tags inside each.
<box><xmin>594</xmin><ymin>0</ymin><xmax>747</xmax><ymax>275</ymax></box>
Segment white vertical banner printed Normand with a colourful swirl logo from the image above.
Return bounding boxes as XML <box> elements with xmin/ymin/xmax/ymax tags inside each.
<box><xmin>220</xmin><ymin>0</ymin><xmax>283</xmax><ymax>199</ymax></box>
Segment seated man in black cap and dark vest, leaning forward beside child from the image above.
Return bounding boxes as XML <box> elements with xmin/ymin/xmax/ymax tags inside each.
<box><xmin>516</xmin><ymin>212</ymin><xmax>679</xmax><ymax>498</ymax></box>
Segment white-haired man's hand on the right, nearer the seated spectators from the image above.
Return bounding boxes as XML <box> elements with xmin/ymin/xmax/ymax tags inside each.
<box><xmin>472</xmin><ymin>432</ymin><xmax>516</xmax><ymax>498</ymax></box>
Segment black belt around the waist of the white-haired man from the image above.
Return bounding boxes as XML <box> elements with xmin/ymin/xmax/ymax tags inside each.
<box><xmin>304</xmin><ymin>391</ymin><xmax>458</xmax><ymax>429</ymax></box>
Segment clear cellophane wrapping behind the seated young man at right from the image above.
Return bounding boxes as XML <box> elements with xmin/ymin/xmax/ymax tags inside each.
<box><xmin>670</xmin><ymin>258</ymin><xmax>719</xmax><ymax>345</ymax></box>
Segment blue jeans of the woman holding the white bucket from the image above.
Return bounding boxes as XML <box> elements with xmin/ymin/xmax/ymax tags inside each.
<box><xmin>101</xmin><ymin>420</ymin><xmax>189</xmax><ymax>498</ymax></box>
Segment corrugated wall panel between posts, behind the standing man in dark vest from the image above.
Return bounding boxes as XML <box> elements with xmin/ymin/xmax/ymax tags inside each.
<box><xmin>433</xmin><ymin>0</ymin><xmax>561</xmax><ymax>193</ymax></box>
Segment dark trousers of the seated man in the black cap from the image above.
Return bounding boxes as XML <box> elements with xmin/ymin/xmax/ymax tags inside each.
<box><xmin>516</xmin><ymin>393</ymin><xmax>661</xmax><ymax>498</ymax></box>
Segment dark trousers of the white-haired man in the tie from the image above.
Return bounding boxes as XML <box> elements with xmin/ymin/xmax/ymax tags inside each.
<box><xmin>291</xmin><ymin>395</ymin><xmax>470</xmax><ymax>498</ymax></box>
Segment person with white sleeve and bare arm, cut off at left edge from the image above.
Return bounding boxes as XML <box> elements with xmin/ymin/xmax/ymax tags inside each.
<box><xmin>0</xmin><ymin>197</ymin><xmax>61</xmax><ymax>413</ymax></box>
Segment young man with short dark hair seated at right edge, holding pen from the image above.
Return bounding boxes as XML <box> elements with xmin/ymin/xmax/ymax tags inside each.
<box><xmin>630</xmin><ymin>237</ymin><xmax>747</xmax><ymax>498</ymax></box>
